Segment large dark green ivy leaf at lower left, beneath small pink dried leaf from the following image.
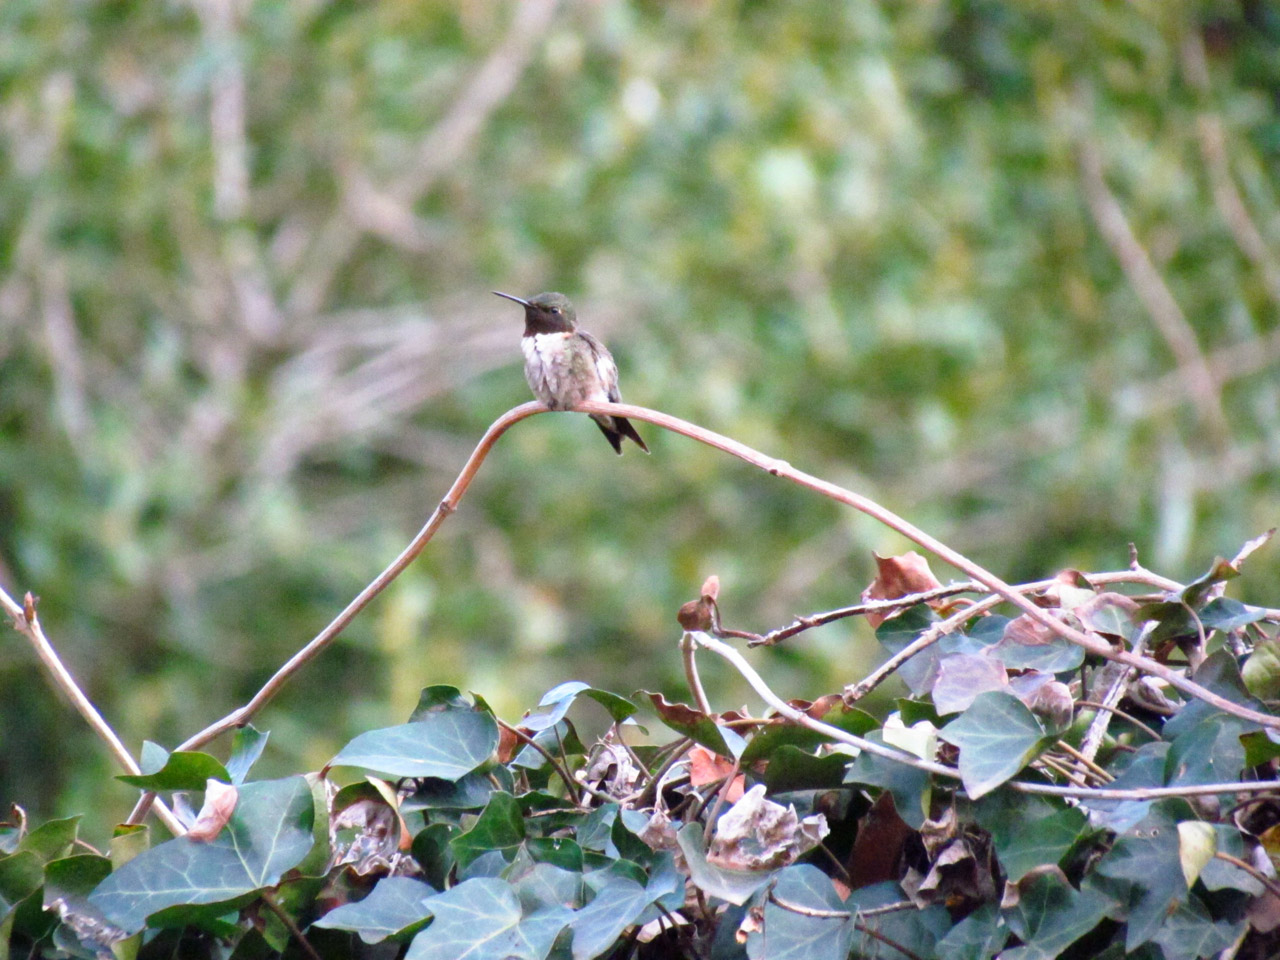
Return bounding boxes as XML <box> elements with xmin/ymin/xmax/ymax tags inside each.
<box><xmin>90</xmin><ymin>777</ymin><xmax>314</xmax><ymax>933</ymax></box>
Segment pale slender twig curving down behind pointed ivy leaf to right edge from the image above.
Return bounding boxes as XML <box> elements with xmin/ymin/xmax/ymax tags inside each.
<box><xmin>694</xmin><ymin>632</ymin><xmax>1277</xmax><ymax>800</ymax></box>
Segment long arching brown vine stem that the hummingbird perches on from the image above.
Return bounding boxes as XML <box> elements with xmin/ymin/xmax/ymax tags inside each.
<box><xmin>120</xmin><ymin>401</ymin><xmax>1280</xmax><ymax>823</ymax></box>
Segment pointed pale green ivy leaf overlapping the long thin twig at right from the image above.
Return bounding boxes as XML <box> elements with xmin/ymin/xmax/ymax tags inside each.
<box><xmin>938</xmin><ymin>690</ymin><xmax>1048</xmax><ymax>800</ymax></box>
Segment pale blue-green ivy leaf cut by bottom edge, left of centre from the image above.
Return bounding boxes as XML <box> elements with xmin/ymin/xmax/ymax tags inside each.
<box><xmin>404</xmin><ymin>878</ymin><xmax>572</xmax><ymax>960</ymax></box>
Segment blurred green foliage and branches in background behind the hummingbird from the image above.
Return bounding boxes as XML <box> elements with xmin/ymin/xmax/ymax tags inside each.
<box><xmin>0</xmin><ymin>0</ymin><xmax>1280</xmax><ymax>823</ymax></box>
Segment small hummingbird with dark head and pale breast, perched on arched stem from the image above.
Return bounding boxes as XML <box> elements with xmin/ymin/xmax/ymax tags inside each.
<box><xmin>494</xmin><ymin>291</ymin><xmax>649</xmax><ymax>456</ymax></box>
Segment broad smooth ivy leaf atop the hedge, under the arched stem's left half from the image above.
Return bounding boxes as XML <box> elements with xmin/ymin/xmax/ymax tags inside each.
<box><xmin>329</xmin><ymin>707</ymin><xmax>498</xmax><ymax>780</ymax></box>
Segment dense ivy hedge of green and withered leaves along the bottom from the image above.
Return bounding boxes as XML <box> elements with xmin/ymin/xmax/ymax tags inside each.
<box><xmin>0</xmin><ymin>544</ymin><xmax>1280</xmax><ymax>960</ymax></box>
